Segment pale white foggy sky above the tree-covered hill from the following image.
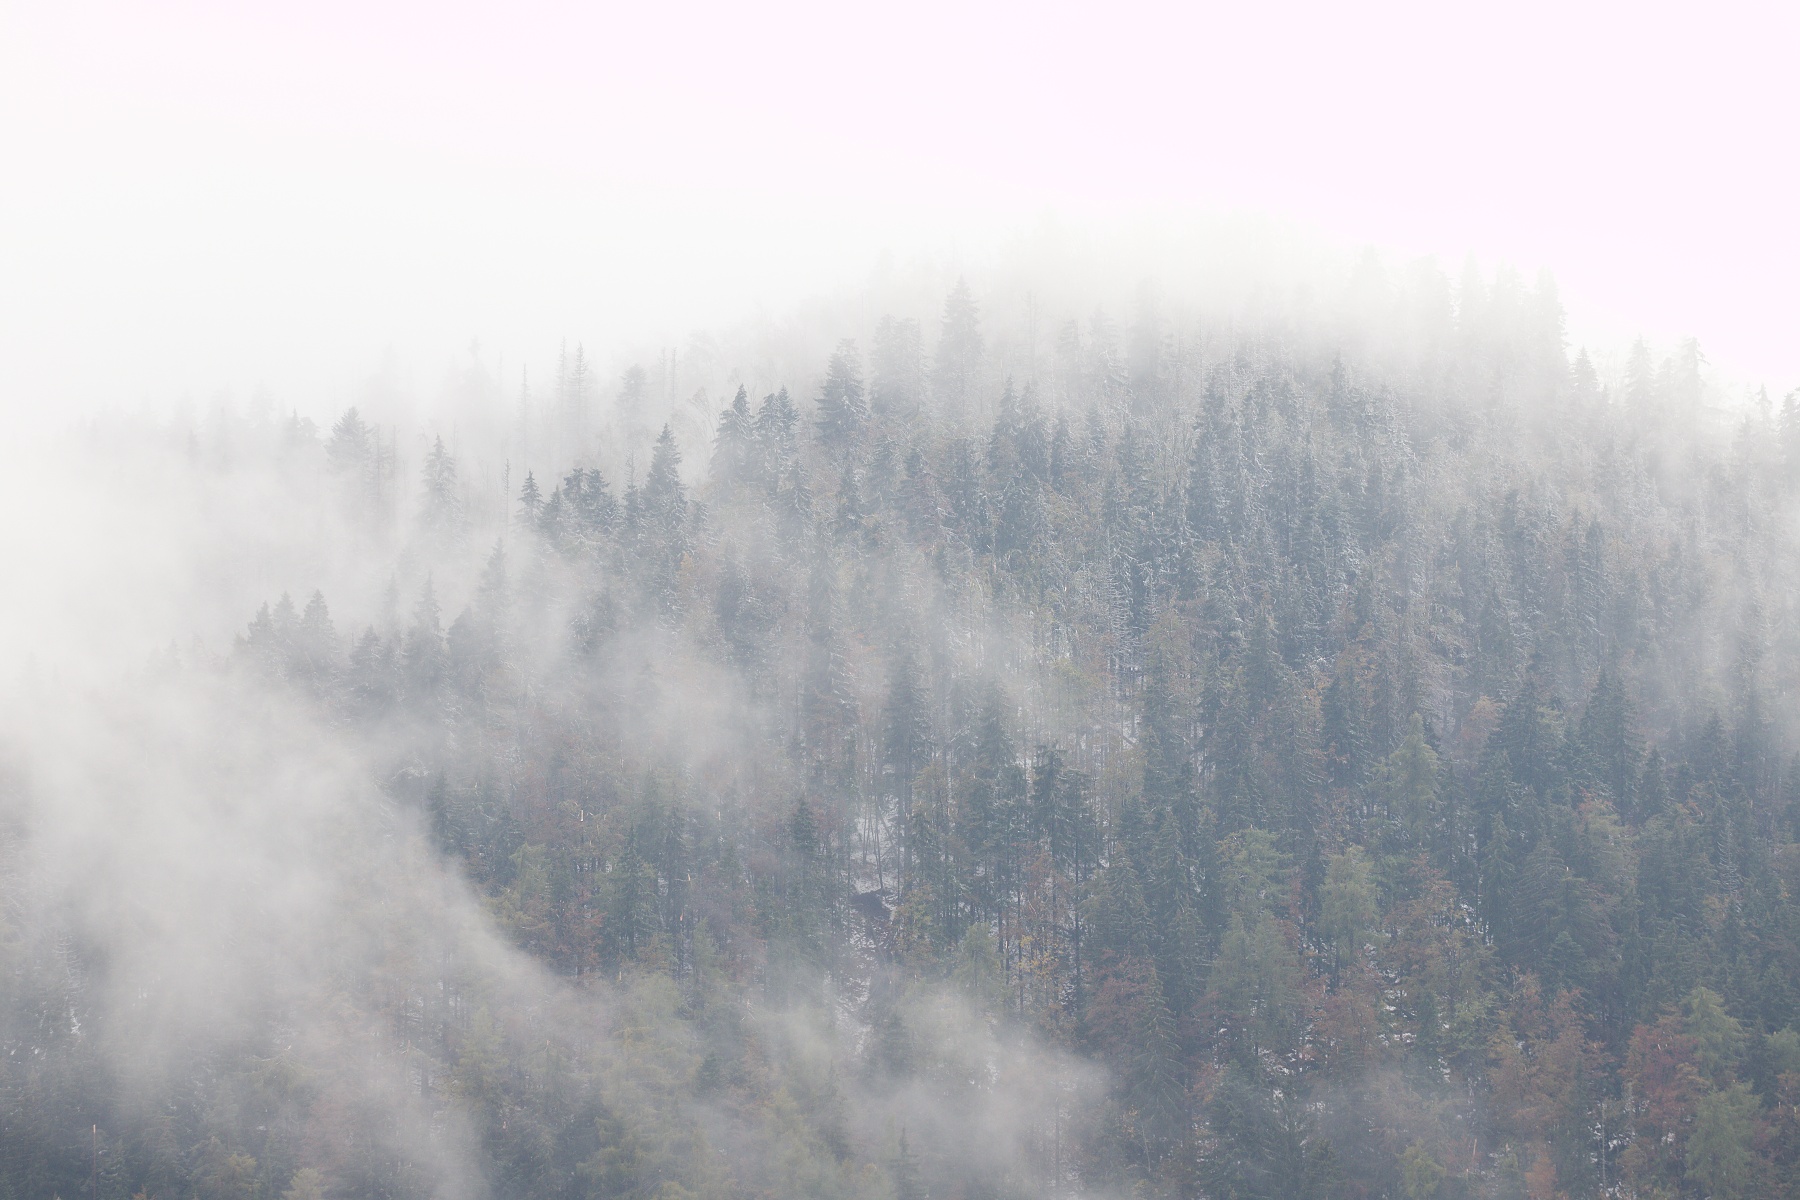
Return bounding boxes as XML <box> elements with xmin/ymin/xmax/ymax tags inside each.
<box><xmin>0</xmin><ymin>2</ymin><xmax>1800</xmax><ymax>421</ymax></box>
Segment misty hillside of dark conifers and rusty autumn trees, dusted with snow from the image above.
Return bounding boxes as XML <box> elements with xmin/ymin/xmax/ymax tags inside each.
<box><xmin>0</xmin><ymin>271</ymin><xmax>1800</xmax><ymax>1200</ymax></box>
